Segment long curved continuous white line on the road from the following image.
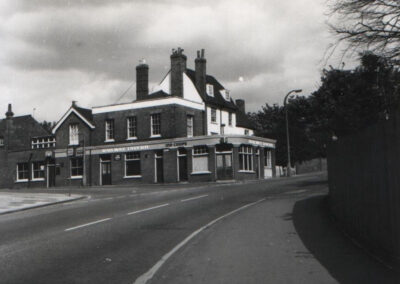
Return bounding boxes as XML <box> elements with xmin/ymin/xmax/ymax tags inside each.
<box><xmin>134</xmin><ymin>198</ymin><xmax>266</xmax><ymax>284</ymax></box>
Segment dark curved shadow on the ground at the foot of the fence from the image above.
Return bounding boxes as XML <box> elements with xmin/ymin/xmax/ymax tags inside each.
<box><xmin>293</xmin><ymin>195</ymin><xmax>400</xmax><ymax>284</ymax></box>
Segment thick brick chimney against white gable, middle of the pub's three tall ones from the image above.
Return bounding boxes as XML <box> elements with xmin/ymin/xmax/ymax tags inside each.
<box><xmin>171</xmin><ymin>47</ymin><xmax>187</xmax><ymax>97</ymax></box>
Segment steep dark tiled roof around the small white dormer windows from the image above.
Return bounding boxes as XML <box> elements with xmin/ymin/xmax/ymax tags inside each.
<box><xmin>186</xmin><ymin>69</ymin><xmax>237</xmax><ymax>110</ymax></box>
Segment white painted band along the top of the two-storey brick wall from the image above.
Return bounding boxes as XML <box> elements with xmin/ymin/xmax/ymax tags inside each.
<box><xmin>92</xmin><ymin>97</ymin><xmax>205</xmax><ymax>114</ymax></box>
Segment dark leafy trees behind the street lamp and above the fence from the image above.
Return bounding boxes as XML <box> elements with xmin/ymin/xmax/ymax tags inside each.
<box><xmin>250</xmin><ymin>53</ymin><xmax>400</xmax><ymax>166</ymax></box>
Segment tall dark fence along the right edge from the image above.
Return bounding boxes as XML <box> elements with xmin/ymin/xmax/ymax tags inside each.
<box><xmin>328</xmin><ymin>115</ymin><xmax>400</xmax><ymax>262</ymax></box>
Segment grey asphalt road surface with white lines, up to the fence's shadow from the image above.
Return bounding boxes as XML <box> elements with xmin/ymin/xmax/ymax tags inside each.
<box><xmin>0</xmin><ymin>175</ymin><xmax>398</xmax><ymax>283</ymax></box>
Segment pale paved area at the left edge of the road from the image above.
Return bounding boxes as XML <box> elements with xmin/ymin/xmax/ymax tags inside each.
<box><xmin>0</xmin><ymin>192</ymin><xmax>84</xmax><ymax>214</ymax></box>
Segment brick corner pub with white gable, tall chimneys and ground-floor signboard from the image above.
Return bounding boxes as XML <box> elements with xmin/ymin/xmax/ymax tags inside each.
<box><xmin>0</xmin><ymin>48</ymin><xmax>275</xmax><ymax>187</ymax></box>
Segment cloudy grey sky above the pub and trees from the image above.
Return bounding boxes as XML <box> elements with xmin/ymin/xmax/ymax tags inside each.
<box><xmin>0</xmin><ymin>0</ymin><xmax>350</xmax><ymax>121</ymax></box>
